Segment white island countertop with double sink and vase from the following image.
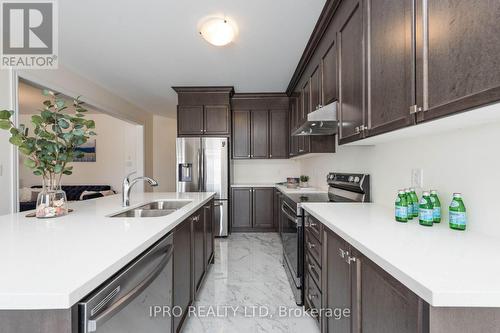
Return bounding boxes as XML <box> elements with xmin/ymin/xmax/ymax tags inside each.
<box><xmin>0</xmin><ymin>193</ymin><xmax>214</xmax><ymax>310</ymax></box>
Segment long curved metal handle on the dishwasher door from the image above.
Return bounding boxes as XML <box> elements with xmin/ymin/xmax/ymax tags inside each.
<box><xmin>87</xmin><ymin>251</ymin><xmax>172</xmax><ymax>332</ymax></box>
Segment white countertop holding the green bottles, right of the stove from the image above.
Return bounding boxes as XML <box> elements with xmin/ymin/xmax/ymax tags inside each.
<box><xmin>302</xmin><ymin>203</ymin><xmax>500</xmax><ymax>307</ymax></box>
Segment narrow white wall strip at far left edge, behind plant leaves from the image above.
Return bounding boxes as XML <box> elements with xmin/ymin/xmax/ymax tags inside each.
<box><xmin>0</xmin><ymin>70</ymin><xmax>14</xmax><ymax>215</ymax></box>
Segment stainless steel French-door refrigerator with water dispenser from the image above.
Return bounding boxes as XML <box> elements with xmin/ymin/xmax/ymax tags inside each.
<box><xmin>177</xmin><ymin>137</ymin><xmax>229</xmax><ymax>237</ymax></box>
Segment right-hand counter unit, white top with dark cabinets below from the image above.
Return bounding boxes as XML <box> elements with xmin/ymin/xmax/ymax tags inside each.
<box><xmin>302</xmin><ymin>203</ymin><xmax>500</xmax><ymax>333</ymax></box>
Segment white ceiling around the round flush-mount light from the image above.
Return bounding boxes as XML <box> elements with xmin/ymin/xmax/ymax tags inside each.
<box><xmin>59</xmin><ymin>0</ymin><xmax>325</xmax><ymax>116</ymax></box>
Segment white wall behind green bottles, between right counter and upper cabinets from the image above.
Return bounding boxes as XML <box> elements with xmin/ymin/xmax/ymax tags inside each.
<box><xmin>300</xmin><ymin>104</ymin><xmax>500</xmax><ymax>234</ymax></box>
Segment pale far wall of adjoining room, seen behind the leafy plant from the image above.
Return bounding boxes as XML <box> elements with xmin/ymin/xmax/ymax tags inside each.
<box><xmin>19</xmin><ymin>114</ymin><xmax>138</xmax><ymax>192</ymax></box>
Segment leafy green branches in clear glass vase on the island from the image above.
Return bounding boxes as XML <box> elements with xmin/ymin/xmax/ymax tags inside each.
<box><xmin>0</xmin><ymin>90</ymin><xmax>96</xmax><ymax>218</ymax></box>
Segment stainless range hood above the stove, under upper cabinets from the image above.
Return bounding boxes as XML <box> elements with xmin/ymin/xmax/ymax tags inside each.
<box><xmin>292</xmin><ymin>101</ymin><xmax>338</xmax><ymax>136</ymax></box>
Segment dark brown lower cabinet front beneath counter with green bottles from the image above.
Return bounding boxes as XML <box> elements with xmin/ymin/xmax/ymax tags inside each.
<box><xmin>304</xmin><ymin>216</ymin><xmax>430</xmax><ymax>333</ymax></box>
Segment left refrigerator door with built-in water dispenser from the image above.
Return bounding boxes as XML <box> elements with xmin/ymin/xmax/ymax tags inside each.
<box><xmin>176</xmin><ymin>137</ymin><xmax>202</xmax><ymax>192</ymax></box>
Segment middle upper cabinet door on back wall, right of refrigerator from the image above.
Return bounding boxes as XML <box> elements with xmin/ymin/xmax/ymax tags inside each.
<box><xmin>250</xmin><ymin>110</ymin><xmax>269</xmax><ymax>158</ymax></box>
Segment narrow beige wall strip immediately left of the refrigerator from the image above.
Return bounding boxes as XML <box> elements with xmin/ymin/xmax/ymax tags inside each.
<box><xmin>153</xmin><ymin>115</ymin><xmax>177</xmax><ymax>192</ymax></box>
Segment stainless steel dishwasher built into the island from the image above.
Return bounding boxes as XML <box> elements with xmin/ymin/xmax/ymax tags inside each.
<box><xmin>78</xmin><ymin>235</ymin><xmax>173</xmax><ymax>333</ymax></box>
